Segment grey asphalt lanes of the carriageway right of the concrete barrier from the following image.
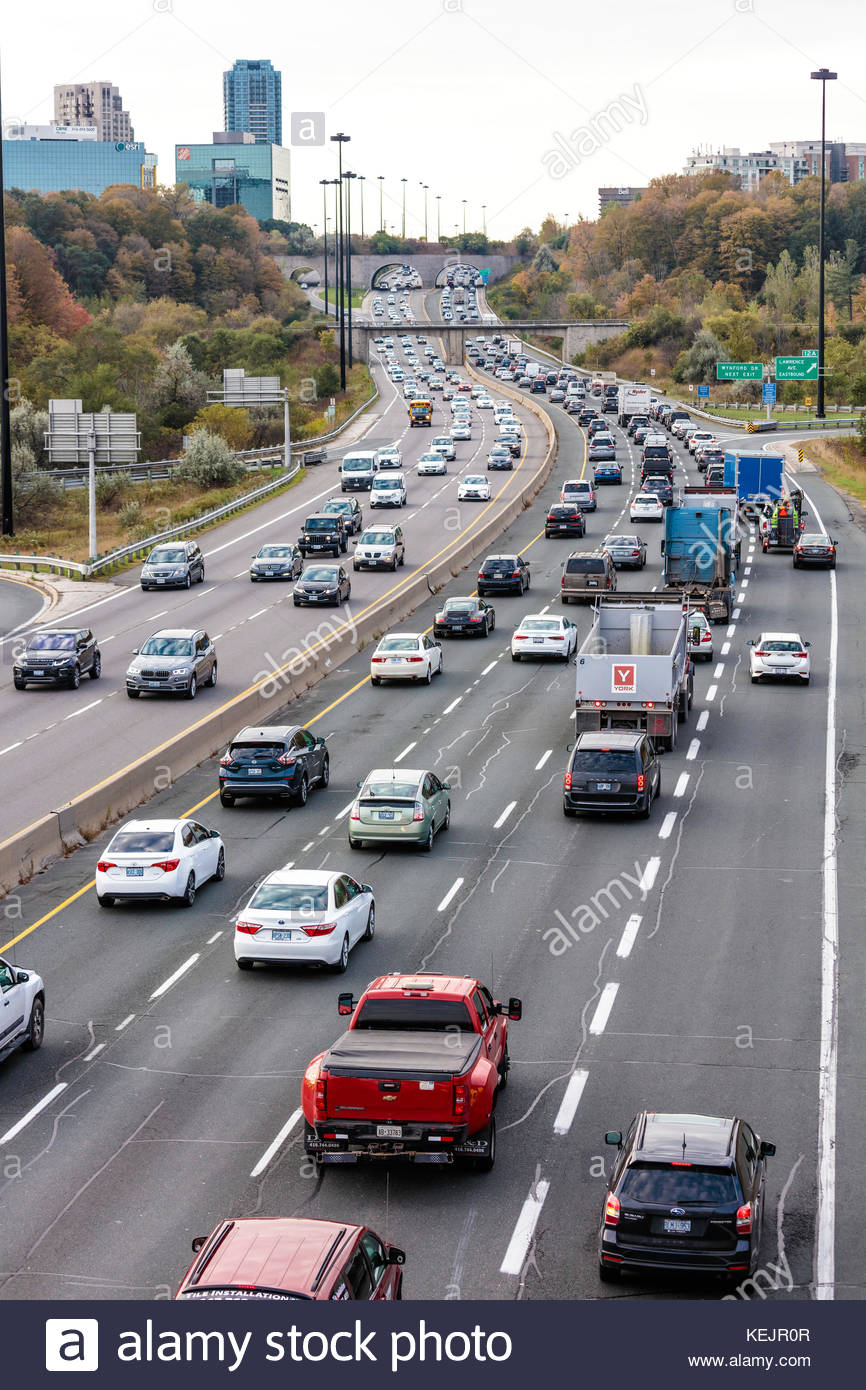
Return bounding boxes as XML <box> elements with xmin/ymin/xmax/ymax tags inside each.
<box><xmin>0</xmin><ymin>318</ymin><xmax>866</xmax><ymax>1300</ymax></box>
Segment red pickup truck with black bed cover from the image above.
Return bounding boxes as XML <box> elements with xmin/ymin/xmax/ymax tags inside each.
<box><xmin>302</xmin><ymin>973</ymin><xmax>523</xmax><ymax>1173</ymax></box>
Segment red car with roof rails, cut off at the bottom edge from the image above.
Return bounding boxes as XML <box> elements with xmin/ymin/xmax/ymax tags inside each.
<box><xmin>175</xmin><ymin>1216</ymin><xmax>406</xmax><ymax>1301</ymax></box>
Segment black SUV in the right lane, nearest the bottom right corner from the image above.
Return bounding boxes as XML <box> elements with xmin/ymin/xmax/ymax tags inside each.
<box><xmin>598</xmin><ymin>1111</ymin><xmax>776</xmax><ymax>1283</ymax></box>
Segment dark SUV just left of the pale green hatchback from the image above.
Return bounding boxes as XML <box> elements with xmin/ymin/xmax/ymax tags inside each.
<box><xmin>220</xmin><ymin>724</ymin><xmax>331</xmax><ymax>806</ymax></box>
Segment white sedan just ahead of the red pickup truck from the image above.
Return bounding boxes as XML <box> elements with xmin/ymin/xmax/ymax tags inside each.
<box><xmin>235</xmin><ymin>869</ymin><xmax>375</xmax><ymax>974</ymax></box>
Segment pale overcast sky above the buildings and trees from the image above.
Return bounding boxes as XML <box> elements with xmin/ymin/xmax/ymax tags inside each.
<box><xmin>1</xmin><ymin>0</ymin><xmax>866</xmax><ymax>238</ymax></box>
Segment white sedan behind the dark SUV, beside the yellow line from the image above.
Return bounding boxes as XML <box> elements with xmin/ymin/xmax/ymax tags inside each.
<box><xmin>96</xmin><ymin>820</ymin><xmax>225</xmax><ymax>908</ymax></box>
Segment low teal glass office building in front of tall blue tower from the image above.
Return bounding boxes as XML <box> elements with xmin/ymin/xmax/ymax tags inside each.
<box><xmin>175</xmin><ymin>131</ymin><xmax>292</xmax><ymax>222</ymax></box>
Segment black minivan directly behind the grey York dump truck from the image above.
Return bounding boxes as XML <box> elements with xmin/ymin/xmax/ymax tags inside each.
<box><xmin>563</xmin><ymin>728</ymin><xmax>662</xmax><ymax>820</ymax></box>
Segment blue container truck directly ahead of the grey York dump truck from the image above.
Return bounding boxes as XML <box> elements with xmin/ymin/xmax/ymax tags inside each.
<box><xmin>662</xmin><ymin>487</ymin><xmax>740</xmax><ymax>623</ymax></box>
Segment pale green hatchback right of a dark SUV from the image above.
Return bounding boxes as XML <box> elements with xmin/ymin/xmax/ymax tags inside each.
<box><xmin>349</xmin><ymin>767</ymin><xmax>450</xmax><ymax>852</ymax></box>
